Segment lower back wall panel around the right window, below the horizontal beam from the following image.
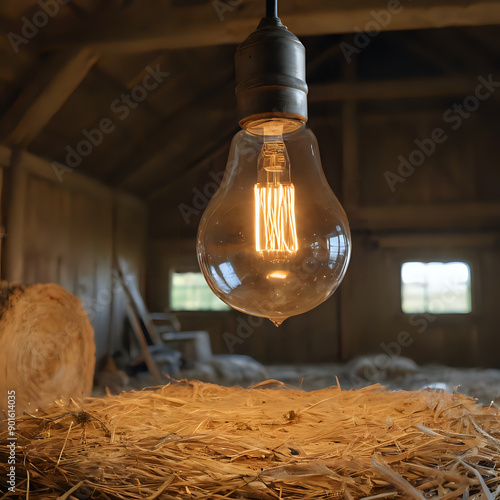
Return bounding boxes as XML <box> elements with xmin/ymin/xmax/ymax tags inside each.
<box><xmin>342</xmin><ymin>232</ymin><xmax>500</xmax><ymax>367</ymax></box>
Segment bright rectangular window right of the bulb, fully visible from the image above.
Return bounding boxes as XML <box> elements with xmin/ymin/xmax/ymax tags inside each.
<box><xmin>401</xmin><ymin>262</ymin><xmax>471</xmax><ymax>314</ymax></box>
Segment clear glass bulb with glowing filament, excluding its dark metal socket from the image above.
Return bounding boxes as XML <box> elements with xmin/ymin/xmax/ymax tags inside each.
<box><xmin>197</xmin><ymin>118</ymin><xmax>351</xmax><ymax>326</ymax></box>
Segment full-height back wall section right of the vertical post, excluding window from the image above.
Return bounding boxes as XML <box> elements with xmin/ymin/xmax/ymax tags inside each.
<box><xmin>341</xmin><ymin>98</ymin><xmax>500</xmax><ymax>366</ymax></box>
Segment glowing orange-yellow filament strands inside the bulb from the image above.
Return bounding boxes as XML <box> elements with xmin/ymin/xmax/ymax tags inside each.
<box><xmin>254</xmin><ymin>182</ymin><xmax>298</xmax><ymax>261</ymax></box>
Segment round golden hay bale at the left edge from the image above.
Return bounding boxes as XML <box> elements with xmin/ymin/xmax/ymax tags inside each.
<box><xmin>0</xmin><ymin>284</ymin><xmax>95</xmax><ymax>415</ymax></box>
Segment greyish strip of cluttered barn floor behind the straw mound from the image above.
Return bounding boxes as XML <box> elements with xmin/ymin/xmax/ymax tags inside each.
<box><xmin>93</xmin><ymin>355</ymin><xmax>500</xmax><ymax>406</ymax></box>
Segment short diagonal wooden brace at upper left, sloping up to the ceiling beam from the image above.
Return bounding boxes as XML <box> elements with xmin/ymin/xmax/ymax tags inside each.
<box><xmin>0</xmin><ymin>48</ymin><xmax>99</xmax><ymax>147</ymax></box>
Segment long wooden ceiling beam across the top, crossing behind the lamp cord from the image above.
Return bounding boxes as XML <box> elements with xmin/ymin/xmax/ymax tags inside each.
<box><xmin>40</xmin><ymin>0</ymin><xmax>500</xmax><ymax>54</ymax></box>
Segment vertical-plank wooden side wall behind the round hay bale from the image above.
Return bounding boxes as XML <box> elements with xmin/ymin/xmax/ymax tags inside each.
<box><xmin>2</xmin><ymin>149</ymin><xmax>146</xmax><ymax>368</ymax></box>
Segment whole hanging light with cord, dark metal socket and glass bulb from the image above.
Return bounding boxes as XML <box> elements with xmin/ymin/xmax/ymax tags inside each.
<box><xmin>197</xmin><ymin>1</ymin><xmax>351</xmax><ymax>326</ymax></box>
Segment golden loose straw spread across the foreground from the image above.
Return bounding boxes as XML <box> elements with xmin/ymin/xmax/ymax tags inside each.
<box><xmin>0</xmin><ymin>381</ymin><xmax>500</xmax><ymax>500</ymax></box>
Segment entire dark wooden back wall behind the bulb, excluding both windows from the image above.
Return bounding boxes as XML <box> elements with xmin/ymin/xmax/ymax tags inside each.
<box><xmin>147</xmin><ymin>93</ymin><xmax>500</xmax><ymax>366</ymax></box>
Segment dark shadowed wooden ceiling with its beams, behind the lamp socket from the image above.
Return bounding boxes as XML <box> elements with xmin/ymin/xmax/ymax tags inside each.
<box><xmin>0</xmin><ymin>0</ymin><xmax>500</xmax><ymax>199</ymax></box>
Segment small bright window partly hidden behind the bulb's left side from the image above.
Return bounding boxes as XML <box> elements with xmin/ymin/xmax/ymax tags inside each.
<box><xmin>170</xmin><ymin>273</ymin><xmax>230</xmax><ymax>311</ymax></box>
